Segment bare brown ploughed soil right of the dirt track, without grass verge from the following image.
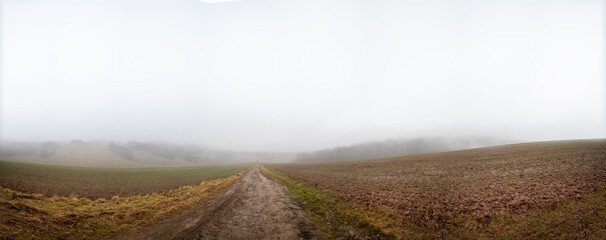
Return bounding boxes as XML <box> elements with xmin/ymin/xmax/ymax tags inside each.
<box><xmin>268</xmin><ymin>140</ymin><xmax>606</xmax><ymax>229</ymax></box>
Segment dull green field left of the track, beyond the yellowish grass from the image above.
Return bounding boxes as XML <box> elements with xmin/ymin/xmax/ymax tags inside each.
<box><xmin>0</xmin><ymin>161</ymin><xmax>252</xmax><ymax>199</ymax></box>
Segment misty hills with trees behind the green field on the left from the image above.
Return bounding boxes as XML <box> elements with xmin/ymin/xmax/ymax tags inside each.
<box><xmin>0</xmin><ymin>140</ymin><xmax>295</xmax><ymax>167</ymax></box>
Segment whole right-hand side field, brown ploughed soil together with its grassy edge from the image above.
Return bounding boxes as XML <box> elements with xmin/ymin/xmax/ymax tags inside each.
<box><xmin>265</xmin><ymin>140</ymin><xmax>606</xmax><ymax>239</ymax></box>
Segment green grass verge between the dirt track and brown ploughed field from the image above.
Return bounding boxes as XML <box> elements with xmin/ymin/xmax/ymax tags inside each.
<box><xmin>261</xmin><ymin>167</ymin><xmax>395</xmax><ymax>239</ymax></box>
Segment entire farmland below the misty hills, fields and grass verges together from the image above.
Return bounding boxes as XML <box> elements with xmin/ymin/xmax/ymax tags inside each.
<box><xmin>0</xmin><ymin>140</ymin><xmax>606</xmax><ymax>239</ymax></box>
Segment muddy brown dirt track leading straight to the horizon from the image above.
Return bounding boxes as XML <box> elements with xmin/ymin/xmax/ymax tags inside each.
<box><xmin>125</xmin><ymin>164</ymin><xmax>315</xmax><ymax>239</ymax></box>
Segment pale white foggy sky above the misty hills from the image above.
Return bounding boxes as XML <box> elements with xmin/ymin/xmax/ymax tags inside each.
<box><xmin>0</xmin><ymin>0</ymin><xmax>606</xmax><ymax>151</ymax></box>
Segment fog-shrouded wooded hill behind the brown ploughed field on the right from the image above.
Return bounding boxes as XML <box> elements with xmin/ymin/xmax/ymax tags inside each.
<box><xmin>296</xmin><ymin>137</ymin><xmax>513</xmax><ymax>162</ymax></box>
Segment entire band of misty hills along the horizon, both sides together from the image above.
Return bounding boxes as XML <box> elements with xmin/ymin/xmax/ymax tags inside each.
<box><xmin>0</xmin><ymin>138</ymin><xmax>511</xmax><ymax>167</ymax></box>
